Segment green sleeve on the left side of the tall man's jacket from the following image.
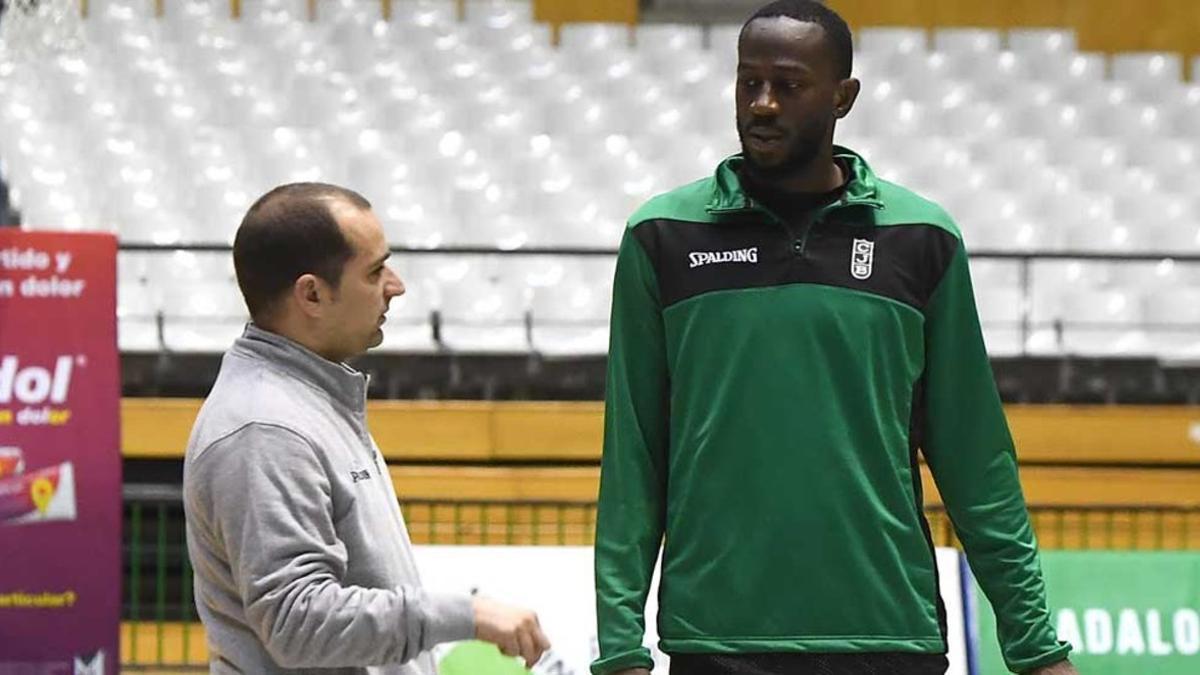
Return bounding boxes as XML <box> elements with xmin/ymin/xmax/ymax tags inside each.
<box><xmin>592</xmin><ymin>231</ymin><xmax>668</xmax><ymax>675</ymax></box>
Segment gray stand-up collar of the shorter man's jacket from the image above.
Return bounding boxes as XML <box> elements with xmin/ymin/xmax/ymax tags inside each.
<box><xmin>230</xmin><ymin>323</ymin><xmax>367</xmax><ymax>418</ymax></box>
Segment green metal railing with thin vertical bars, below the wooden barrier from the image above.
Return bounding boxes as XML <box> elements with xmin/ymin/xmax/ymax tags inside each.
<box><xmin>121</xmin><ymin>485</ymin><xmax>1200</xmax><ymax>673</ymax></box>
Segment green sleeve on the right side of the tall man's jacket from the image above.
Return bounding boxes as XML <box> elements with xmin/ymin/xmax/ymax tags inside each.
<box><xmin>922</xmin><ymin>243</ymin><xmax>1070</xmax><ymax>673</ymax></box>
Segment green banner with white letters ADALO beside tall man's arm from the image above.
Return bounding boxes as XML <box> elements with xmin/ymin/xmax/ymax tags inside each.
<box><xmin>976</xmin><ymin>551</ymin><xmax>1200</xmax><ymax>675</ymax></box>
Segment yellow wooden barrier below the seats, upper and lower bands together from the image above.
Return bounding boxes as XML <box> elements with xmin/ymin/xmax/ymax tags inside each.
<box><xmin>121</xmin><ymin>399</ymin><xmax>1200</xmax><ymax>507</ymax></box>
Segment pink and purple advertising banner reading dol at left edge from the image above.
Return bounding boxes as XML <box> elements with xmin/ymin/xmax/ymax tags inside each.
<box><xmin>0</xmin><ymin>228</ymin><xmax>121</xmax><ymax>675</ymax></box>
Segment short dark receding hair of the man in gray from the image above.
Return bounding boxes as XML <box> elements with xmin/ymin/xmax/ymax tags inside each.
<box><xmin>233</xmin><ymin>183</ymin><xmax>371</xmax><ymax>319</ymax></box>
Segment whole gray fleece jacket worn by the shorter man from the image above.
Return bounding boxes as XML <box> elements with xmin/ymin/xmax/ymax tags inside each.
<box><xmin>184</xmin><ymin>325</ymin><xmax>474</xmax><ymax>675</ymax></box>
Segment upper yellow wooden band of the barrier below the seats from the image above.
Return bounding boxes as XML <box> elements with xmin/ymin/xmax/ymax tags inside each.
<box><xmin>121</xmin><ymin>399</ymin><xmax>1200</xmax><ymax>466</ymax></box>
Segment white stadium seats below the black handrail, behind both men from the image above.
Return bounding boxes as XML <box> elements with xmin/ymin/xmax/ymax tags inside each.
<box><xmin>118</xmin><ymin>252</ymin><xmax>1200</xmax><ymax>357</ymax></box>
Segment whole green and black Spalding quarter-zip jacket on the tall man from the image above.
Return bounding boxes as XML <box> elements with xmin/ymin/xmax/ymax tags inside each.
<box><xmin>593</xmin><ymin>148</ymin><xmax>1069</xmax><ymax>674</ymax></box>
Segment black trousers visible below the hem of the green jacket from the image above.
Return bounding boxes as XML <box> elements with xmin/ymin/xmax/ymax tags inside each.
<box><xmin>671</xmin><ymin>652</ymin><xmax>950</xmax><ymax>675</ymax></box>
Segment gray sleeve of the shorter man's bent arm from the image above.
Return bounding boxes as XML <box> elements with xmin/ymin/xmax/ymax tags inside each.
<box><xmin>192</xmin><ymin>424</ymin><xmax>474</xmax><ymax>668</ymax></box>
